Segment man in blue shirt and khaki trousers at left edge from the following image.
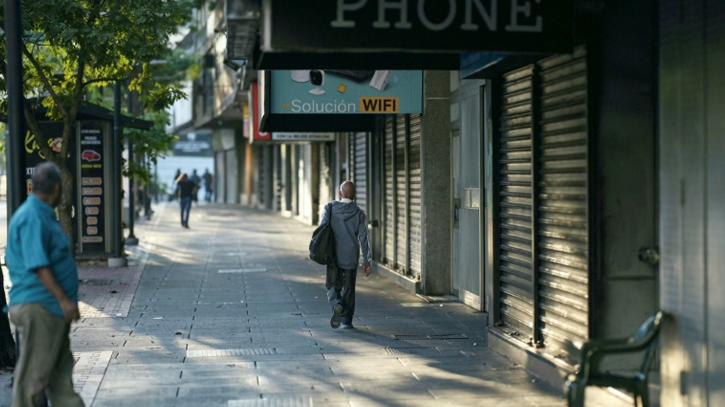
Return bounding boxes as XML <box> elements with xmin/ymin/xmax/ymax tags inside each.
<box><xmin>6</xmin><ymin>162</ymin><xmax>84</xmax><ymax>407</ymax></box>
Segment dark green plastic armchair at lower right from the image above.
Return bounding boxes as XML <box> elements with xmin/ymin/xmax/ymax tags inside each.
<box><xmin>566</xmin><ymin>311</ymin><xmax>666</xmax><ymax>407</ymax></box>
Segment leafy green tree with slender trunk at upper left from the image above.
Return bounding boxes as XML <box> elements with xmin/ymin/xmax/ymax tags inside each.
<box><xmin>0</xmin><ymin>0</ymin><xmax>196</xmax><ymax>242</ymax></box>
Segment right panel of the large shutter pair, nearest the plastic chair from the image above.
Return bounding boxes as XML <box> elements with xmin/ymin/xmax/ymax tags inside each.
<box><xmin>537</xmin><ymin>48</ymin><xmax>589</xmax><ymax>356</ymax></box>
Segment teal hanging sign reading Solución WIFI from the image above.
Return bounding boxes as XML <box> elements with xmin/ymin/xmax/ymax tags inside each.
<box><xmin>269</xmin><ymin>69</ymin><xmax>423</xmax><ymax>114</ymax></box>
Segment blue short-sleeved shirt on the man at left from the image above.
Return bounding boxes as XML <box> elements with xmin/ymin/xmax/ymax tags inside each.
<box><xmin>5</xmin><ymin>195</ymin><xmax>78</xmax><ymax>316</ymax></box>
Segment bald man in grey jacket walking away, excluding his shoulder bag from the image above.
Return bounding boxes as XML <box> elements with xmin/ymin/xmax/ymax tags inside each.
<box><xmin>320</xmin><ymin>181</ymin><xmax>371</xmax><ymax>329</ymax></box>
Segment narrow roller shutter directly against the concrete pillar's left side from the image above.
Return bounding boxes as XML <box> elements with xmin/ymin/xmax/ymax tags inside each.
<box><xmin>408</xmin><ymin>114</ymin><xmax>421</xmax><ymax>276</ymax></box>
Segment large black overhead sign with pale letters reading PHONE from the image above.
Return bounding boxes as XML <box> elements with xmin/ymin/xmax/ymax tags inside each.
<box><xmin>261</xmin><ymin>0</ymin><xmax>573</xmax><ymax>53</ymax></box>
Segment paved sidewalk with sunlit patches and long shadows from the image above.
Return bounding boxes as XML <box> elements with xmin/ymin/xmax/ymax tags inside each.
<box><xmin>5</xmin><ymin>203</ymin><xmax>629</xmax><ymax>407</ymax></box>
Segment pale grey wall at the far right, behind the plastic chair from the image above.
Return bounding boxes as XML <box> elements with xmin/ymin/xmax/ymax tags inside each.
<box><xmin>659</xmin><ymin>0</ymin><xmax>725</xmax><ymax>407</ymax></box>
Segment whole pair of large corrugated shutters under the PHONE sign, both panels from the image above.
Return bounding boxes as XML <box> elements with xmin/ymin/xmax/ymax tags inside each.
<box><xmin>497</xmin><ymin>48</ymin><xmax>589</xmax><ymax>358</ymax></box>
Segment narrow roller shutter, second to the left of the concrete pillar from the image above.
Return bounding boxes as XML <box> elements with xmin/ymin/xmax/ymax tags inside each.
<box><xmin>395</xmin><ymin>115</ymin><xmax>409</xmax><ymax>273</ymax></box>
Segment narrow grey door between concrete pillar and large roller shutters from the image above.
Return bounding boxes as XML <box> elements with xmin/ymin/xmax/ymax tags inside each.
<box><xmin>453</xmin><ymin>93</ymin><xmax>483</xmax><ymax>310</ymax></box>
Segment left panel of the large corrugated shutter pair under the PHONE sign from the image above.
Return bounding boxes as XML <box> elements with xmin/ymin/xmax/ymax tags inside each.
<box><xmin>498</xmin><ymin>65</ymin><xmax>534</xmax><ymax>335</ymax></box>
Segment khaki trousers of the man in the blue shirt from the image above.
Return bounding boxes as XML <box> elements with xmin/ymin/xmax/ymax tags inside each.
<box><xmin>8</xmin><ymin>303</ymin><xmax>85</xmax><ymax>407</ymax></box>
